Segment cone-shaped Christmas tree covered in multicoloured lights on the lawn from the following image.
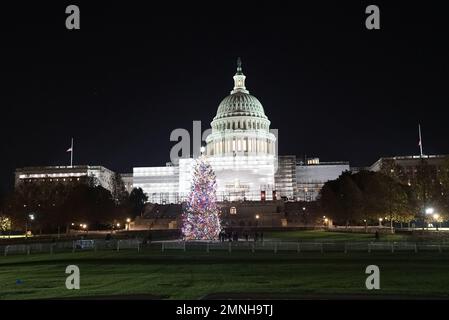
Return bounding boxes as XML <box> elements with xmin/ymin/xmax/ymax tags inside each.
<box><xmin>182</xmin><ymin>156</ymin><xmax>221</xmax><ymax>240</ymax></box>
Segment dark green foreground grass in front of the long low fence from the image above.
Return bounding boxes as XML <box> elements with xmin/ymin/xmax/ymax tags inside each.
<box><xmin>0</xmin><ymin>250</ymin><xmax>449</xmax><ymax>299</ymax></box>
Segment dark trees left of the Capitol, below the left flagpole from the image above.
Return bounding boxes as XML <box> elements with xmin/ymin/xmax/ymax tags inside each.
<box><xmin>0</xmin><ymin>174</ymin><xmax>148</xmax><ymax>232</ymax></box>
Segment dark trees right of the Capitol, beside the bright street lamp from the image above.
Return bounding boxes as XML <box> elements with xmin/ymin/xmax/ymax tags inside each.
<box><xmin>319</xmin><ymin>159</ymin><xmax>449</xmax><ymax>227</ymax></box>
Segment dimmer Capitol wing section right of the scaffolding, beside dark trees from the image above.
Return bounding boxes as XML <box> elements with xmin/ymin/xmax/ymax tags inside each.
<box><xmin>296</xmin><ymin>158</ymin><xmax>350</xmax><ymax>201</ymax></box>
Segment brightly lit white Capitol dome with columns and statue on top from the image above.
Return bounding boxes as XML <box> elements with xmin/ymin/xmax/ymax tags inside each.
<box><xmin>206</xmin><ymin>58</ymin><xmax>276</xmax><ymax>156</ymax></box>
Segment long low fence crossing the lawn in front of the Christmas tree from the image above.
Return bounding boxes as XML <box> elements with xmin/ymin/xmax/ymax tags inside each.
<box><xmin>0</xmin><ymin>239</ymin><xmax>449</xmax><ymax>256</ymax></box>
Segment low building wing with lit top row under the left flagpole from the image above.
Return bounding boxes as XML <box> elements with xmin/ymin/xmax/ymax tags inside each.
<box><xmin>15</xmin><ymin>166</ymin><xmax>114</xmax><ymax>191</ymax></box>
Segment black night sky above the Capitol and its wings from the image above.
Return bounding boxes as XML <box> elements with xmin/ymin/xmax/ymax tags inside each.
<box><xmin>0</xmin><ymin>1</ymin><xmax>449</xmax><ymax>190</ymax></box>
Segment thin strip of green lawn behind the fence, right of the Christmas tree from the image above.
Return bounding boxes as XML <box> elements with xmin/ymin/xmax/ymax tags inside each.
<box><xmin>264</xmin><ymin>230</ymin><xmax>410</xmax><ymax>242</ymax></box>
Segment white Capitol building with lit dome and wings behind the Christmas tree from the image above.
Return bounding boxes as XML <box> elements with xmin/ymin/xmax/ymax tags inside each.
<box><xmin>15</xmin><ymin>59</ymin><xmax>350</xmax><ymax>204</ymax></box>
